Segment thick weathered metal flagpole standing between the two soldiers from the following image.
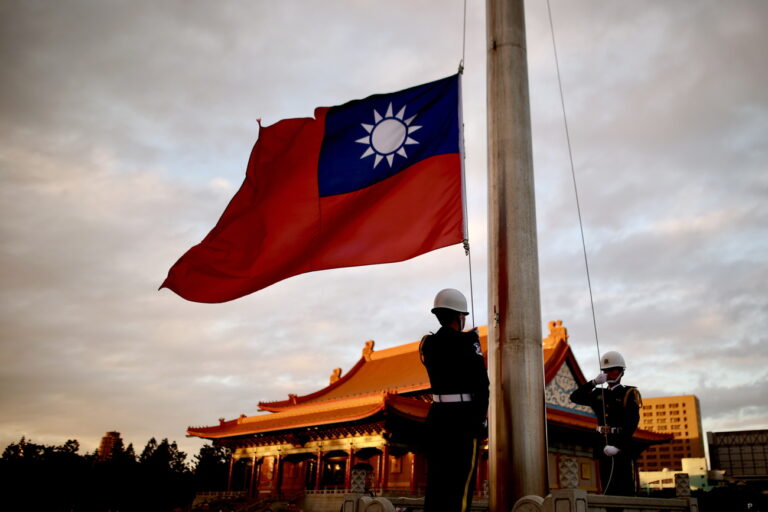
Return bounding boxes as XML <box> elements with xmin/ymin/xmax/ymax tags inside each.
<box><xmin>486</xmin><ymin>0</ymin><xmax>548</xmax><ymax>512</ymax></box>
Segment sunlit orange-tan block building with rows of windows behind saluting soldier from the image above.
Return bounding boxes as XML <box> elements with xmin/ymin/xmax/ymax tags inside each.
<box><xmin>637</xmin><ymin>395</ymin><xmax>704</xmax><ymax>471</ymax></box>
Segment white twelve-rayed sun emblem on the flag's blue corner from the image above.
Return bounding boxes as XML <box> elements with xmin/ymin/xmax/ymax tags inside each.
<box><xmin>355</xmin><ymin>103</ymin><xmax>421</xmax><ymax>169</ymax></box>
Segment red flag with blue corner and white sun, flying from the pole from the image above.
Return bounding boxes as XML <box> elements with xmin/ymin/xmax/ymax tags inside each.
<box><xmin>161</xmin><ymin>75</ymin><xmax>465</xmax><ymax>302</ymax></box>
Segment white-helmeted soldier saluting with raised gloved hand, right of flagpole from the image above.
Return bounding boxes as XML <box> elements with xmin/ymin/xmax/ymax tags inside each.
<box><xmin>571</xmin><ymin>352</ymin><xmax>643</xmax><ymax>496</ymax></box>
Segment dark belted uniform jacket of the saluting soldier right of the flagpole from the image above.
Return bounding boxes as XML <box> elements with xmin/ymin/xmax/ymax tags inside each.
<box><xmin>571</xmin><ymin>381</ymin><xmax>643</xmax><ymax>454</ymax></box>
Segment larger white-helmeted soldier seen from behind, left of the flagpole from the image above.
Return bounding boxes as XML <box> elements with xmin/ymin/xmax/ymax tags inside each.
<box><xmin>419</xmin><ymin>288</ymin><xmax>489</xmax><ymax>512</ymax></box>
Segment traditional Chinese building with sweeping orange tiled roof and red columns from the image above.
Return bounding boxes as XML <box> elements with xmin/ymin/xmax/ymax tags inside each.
<box><xmin>187</xmin><ymin>321</ymin><xmax>671</xmax><ymax>497</ymax></box>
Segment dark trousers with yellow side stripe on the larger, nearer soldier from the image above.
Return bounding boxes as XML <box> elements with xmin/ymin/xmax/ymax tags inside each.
<box><xmin>424</xmin><ymin>403</ymin><xmax>482</xmax><ymax>512</ymax></box>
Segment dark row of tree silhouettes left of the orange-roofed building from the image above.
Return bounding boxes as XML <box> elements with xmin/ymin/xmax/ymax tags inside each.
<box><xmin>0</xmin><ymin>437</ymin><xmax>243</xmax><ymax>512</ymax></box>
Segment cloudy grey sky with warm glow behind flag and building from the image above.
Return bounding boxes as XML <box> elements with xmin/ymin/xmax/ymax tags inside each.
<box><xmin>0</xmin><ymin>0</ymin><xmax>768</xmax><ymax>456</ymax></box>
